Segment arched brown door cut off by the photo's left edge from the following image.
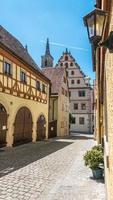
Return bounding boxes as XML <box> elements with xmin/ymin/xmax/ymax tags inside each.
<box><xmin>0</xmin><ymin>104</ymin><xmax>8</xmax><ymax>147</ymax></box>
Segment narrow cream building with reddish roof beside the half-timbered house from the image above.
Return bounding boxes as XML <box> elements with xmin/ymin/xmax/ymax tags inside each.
<box><xmin>43</xmin><ymin>67</ymin><xmax>69</xmax><ymax>137</ymax></box>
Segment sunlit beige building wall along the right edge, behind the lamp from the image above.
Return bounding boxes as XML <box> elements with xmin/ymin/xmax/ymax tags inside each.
<box><xmin>84</xmin><ymin>0</ymin><xmax>113</xmax><ymax>200</ymax></box>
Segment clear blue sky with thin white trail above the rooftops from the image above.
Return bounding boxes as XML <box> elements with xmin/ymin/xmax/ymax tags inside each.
<box><xmin>0</xmin><ymin>0</ymin><xmax>95</xmax><ymax>78</ymax></box>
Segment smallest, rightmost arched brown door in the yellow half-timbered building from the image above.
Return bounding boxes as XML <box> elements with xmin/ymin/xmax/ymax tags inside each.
<box><xmin>37</xmin><ymin>115</ymin><xmax>46</xmax><ymax>140</ymax></box>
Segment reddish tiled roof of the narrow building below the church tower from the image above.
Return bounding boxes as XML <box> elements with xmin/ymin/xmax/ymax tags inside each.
<box><xmin>42</xmin><ymin>67</ymin><xmax>65</xmax><ymax>94</ymax></box>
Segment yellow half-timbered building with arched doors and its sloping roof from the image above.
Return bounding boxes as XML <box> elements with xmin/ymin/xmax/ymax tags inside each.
<box><xmin>0</xmin><ymin>26</ymin><xmax>50</xmax><ymax>147</ymax></box>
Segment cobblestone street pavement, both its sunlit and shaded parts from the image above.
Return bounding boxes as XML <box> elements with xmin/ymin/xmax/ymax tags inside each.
<box><xmin>0</xmin><ymin>136</ymin><xmax>105</xmax><ymax>200</ymax></box>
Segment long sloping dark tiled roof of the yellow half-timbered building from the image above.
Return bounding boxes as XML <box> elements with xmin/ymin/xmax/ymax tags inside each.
<box><xmin>0</xmin><ymin>25</ymin><xmax>50</xmax><ymax>83</ymax></box>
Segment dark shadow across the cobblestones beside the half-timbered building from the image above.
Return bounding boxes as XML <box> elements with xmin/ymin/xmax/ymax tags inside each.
<box><xmin>0</xmin><ymin>140</ymin><xmax>72</xmax><ymax>177</ymax></box>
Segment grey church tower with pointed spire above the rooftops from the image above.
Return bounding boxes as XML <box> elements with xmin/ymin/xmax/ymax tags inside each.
<box><xmin>41</xmin><ymin>38</ymin><xmax>54</xmax><ymax>68</ymax></box>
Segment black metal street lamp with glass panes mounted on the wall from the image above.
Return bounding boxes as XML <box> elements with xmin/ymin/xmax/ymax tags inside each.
<box><xmin>83</xmin><ymin>9</ymin><xmax>107</xmax><ymax>48</ymax></box>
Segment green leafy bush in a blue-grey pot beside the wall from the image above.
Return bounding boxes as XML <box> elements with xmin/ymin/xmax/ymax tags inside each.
<box><xmin>84</xmin><ymin>145</ymin><xmax>104</xmax><ymax>179</ymax></box>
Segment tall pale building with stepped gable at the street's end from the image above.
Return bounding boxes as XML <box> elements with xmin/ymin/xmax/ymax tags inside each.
<box><xmin>57</xmin><ymin>49</ymin><xmax>94</xmax><ymax>133</ymax></box>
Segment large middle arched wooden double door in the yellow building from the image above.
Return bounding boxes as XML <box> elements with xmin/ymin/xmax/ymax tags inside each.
<box><xmin>14</xmin><ymin>107</ymin><xmax>33</xmax><ymax>146</ymax></box>
